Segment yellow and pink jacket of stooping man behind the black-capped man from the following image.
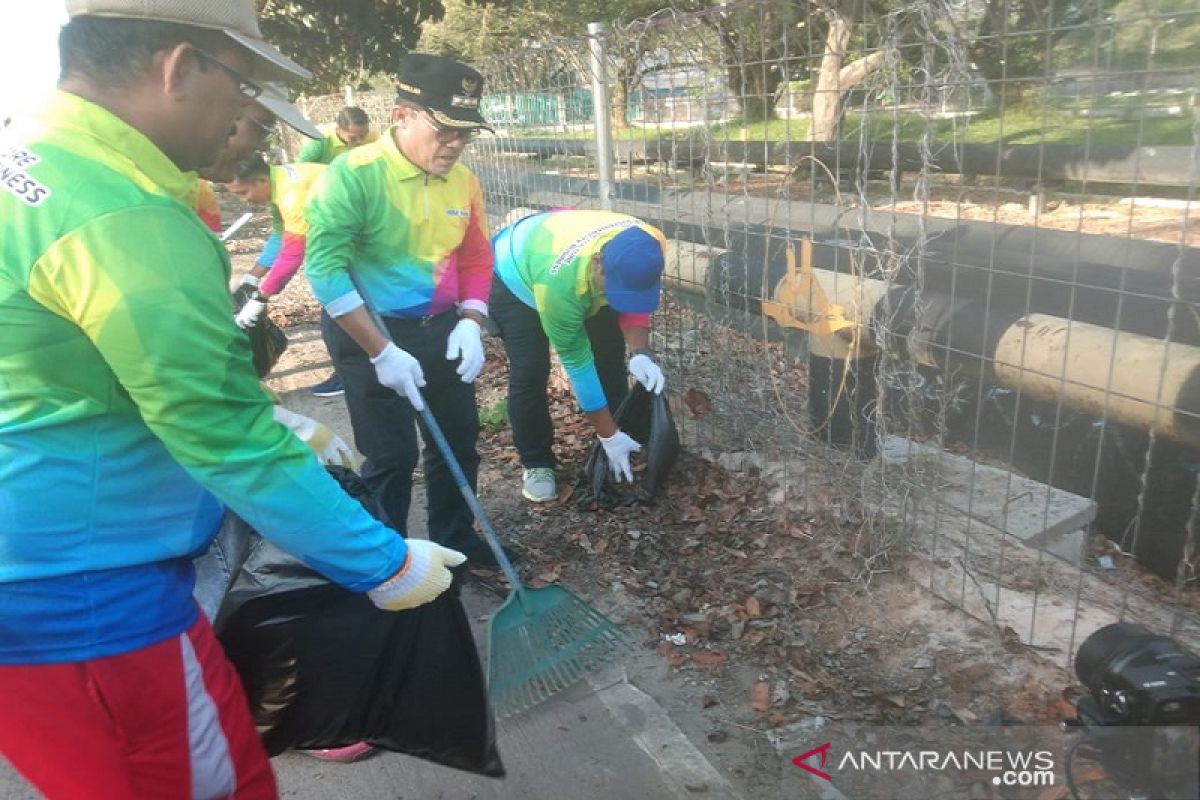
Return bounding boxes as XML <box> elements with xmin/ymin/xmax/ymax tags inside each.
<box><xmin>258</xmin><ymin>164</ymin><xmax>325</xmax><ymax>295</ymax></box>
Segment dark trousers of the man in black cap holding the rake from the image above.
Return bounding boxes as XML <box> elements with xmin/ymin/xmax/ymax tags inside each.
<box><xmin>320</xmin><ymin>312</ymin><xmax>482</xmax><ymax>549</ymax></box>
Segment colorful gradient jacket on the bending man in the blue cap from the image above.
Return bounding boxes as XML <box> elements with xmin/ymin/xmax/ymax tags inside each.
<box><xmin>492</xmin><ymin>210</ymin><xmax>666</xmax><ymax>411</ymax></box>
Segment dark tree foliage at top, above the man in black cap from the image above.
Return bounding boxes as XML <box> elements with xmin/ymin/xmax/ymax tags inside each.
<box><xmin>258</xmin><ymin>0</ymin><xmax>443</xmax><ymax>94</ymax></box>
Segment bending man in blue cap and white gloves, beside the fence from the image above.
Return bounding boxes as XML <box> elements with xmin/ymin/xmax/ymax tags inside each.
<box><xmin>488</xmin><ymin>210</ymin><xmax>666</xmax><ymax>503</ymax></box>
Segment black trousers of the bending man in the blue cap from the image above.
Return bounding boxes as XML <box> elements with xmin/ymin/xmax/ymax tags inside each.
<box><xmin>488</xmin><ymin>278</ymin><xmax>629</xmax><ymax>469</ymax></box>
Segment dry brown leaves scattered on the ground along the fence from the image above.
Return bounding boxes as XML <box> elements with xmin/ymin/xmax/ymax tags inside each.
<box><xmin>468</xmin><ymin>339</ymin><xmax>1070</xmax><ymax>742</ymax></box>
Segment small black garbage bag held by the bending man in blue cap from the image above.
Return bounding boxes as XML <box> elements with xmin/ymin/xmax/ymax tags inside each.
<box><xmin>575</xmin><ymin>384</ymin><xmax>679</xmax><ymax>507</ymax></box>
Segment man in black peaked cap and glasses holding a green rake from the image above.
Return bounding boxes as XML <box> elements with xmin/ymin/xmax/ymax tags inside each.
<box><xmin>306</xmin><ymin>53</ymin><xmax>496</xmax><ymax>565</ymax></box>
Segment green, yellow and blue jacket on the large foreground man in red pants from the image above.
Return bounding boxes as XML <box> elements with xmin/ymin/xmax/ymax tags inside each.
<box><xmin>0</xmin><ymin>92</ymin><xmax>406</xmax><ymax>663</ymax></box>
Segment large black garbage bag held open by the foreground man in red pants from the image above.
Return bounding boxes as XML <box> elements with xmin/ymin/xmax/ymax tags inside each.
<box><xmin>215</xmin><ymin>467</ymin><xmax>504</xmax><ymax>777</ymax></box>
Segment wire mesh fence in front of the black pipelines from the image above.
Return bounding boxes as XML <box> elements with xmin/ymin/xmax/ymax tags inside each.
<box><xmin>297</xmin><ymin>0</ymin><xmax>1200</xmax><ymax>662</ymax></box>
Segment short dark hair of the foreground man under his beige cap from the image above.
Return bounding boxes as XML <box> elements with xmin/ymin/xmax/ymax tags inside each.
<box><xmin>59</xmin><ymin>16</ymin><xmax>233</xmax><ymax>86</ymax></box>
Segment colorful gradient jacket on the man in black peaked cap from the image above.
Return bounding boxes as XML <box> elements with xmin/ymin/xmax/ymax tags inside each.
<box><xmin>305</xmin><ymin>130</ymin><xmax>492</xmax><ymax>318</ymax></box>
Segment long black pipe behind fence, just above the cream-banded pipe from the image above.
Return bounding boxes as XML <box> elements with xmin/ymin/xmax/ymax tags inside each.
<box><xmin>475</xmin><ymin>166</ymin><xmax>1200</xmax><ymax>344</ymax></box>
